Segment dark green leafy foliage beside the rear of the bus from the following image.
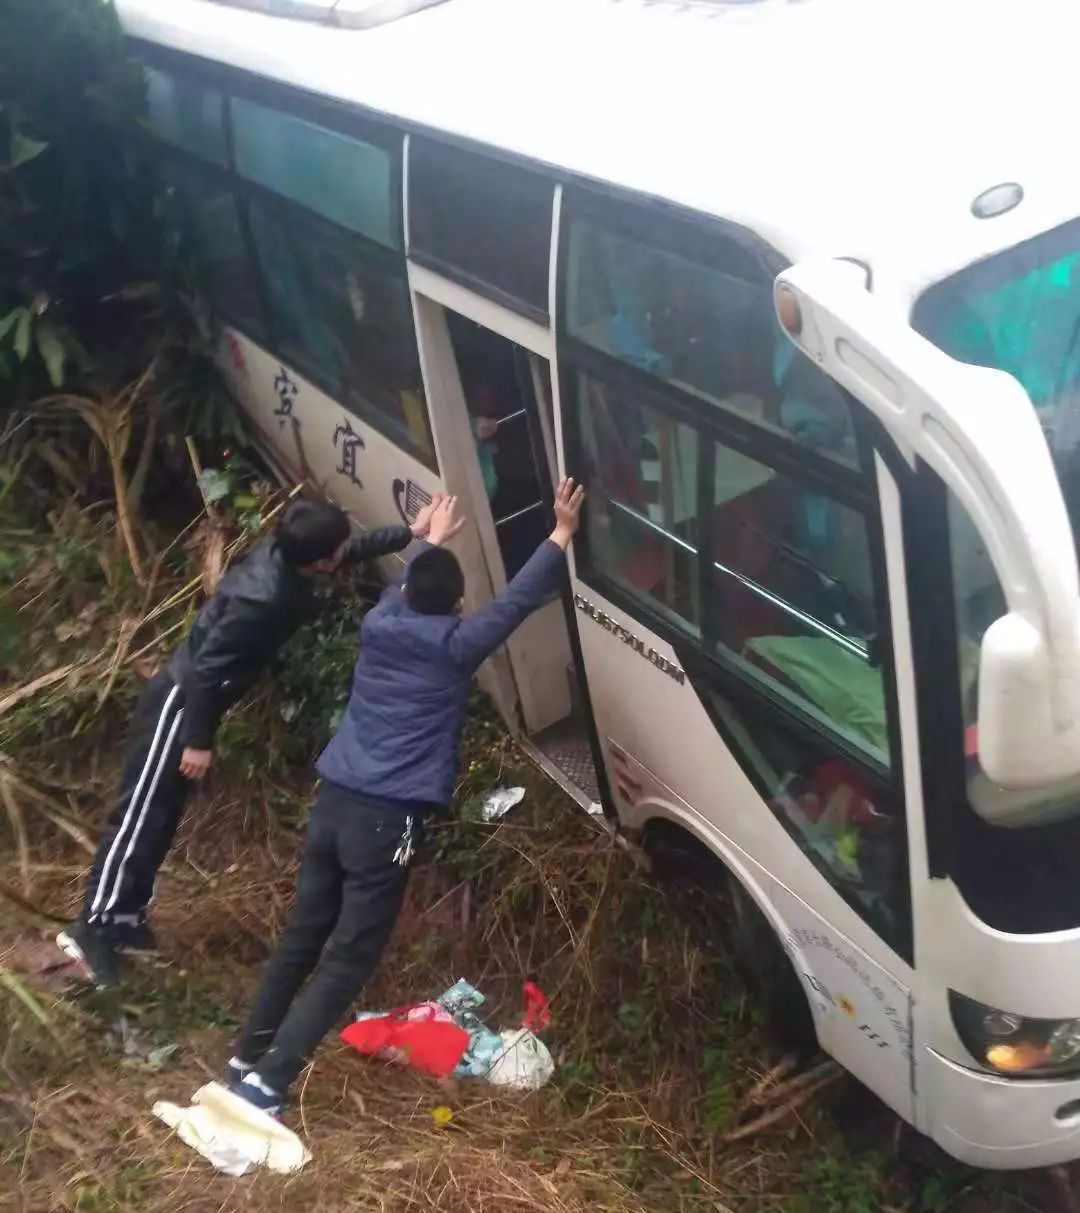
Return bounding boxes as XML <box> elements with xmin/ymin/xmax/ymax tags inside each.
<box><xmin>0</xmin><ymin>0</ymin><xmax>246</xmax><ymax>477</ymax></box>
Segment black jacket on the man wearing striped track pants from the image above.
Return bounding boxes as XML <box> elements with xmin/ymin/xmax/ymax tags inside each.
<box><xmin>169</xmin><ymin>526</ymin><xmax>413</xmax><ymax>750</ymax></box>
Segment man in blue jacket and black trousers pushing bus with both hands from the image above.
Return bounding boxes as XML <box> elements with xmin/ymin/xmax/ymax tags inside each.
<box><xmin>228</xmin><ymin>480</ymin><xmax>584</xmax><ymax>1115</ymax></box>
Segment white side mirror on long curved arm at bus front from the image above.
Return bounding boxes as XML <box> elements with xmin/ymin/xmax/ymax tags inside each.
<box><xmin>774</xmin><ymin>258</ymin><xmax>1080</xmax><ymax>805</ymax></box>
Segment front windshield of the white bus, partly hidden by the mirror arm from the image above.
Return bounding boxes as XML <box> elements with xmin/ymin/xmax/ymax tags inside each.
<box><xmin>913</xmin><ymin>220</ymin><xmax>1080</xmax><ymax>932</ymax></box>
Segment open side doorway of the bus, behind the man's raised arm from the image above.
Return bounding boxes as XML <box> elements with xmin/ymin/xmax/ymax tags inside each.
<box><xmin>444</xmin><ymin>311</ymin><xmax>599</xmax><ymax>804</ymax></box>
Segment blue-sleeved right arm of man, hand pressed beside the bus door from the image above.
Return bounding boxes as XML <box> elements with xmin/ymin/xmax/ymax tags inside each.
<box><xmin>454</xmin><ymin>479</ymin><xmax>585</xmax><ymax>670</ymax></box>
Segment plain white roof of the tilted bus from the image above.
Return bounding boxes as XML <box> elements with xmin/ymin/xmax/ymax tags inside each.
<box><xmin>118</xmin><ymin>0</ymin><xmax>1080</xmax><ymax>306</ymax></box>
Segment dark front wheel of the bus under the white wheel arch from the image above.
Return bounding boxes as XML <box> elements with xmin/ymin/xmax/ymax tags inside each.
<box><xmin>731</xmin><ymin>879</ymin><xmax>818</xmax><ymax>1059</ymax></box>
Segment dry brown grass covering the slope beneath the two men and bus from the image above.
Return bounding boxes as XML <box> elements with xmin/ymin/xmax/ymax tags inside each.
<box><xmin>0</xmin><ymin>446</ymin><xmax>1075</xmax><ymax>1213</ymax></box>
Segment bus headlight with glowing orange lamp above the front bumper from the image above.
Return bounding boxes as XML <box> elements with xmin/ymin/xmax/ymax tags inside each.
<box><xmin>949</xmin><ymin>990</ymin><xmax>1080</xmax><ymax>1076</ymax></box>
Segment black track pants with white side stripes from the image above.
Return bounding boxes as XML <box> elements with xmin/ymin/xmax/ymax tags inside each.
<box><xmin>83</xmin><ymin>671</ymin><xmax>191</xmax><ymax>924</ymax></box>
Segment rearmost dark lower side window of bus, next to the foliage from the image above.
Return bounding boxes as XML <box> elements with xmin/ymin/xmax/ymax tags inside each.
<box><xmin>160</xmin><ymin>156</ymin><xmax>266</xmax><ymax>341</ymax></box>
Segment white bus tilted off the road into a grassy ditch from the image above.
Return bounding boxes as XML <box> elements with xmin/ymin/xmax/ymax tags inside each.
<box><xmin>118</xmin><ymin>0</ymin><xmax>1080</xmax><ymax>1167</ymax></box>
